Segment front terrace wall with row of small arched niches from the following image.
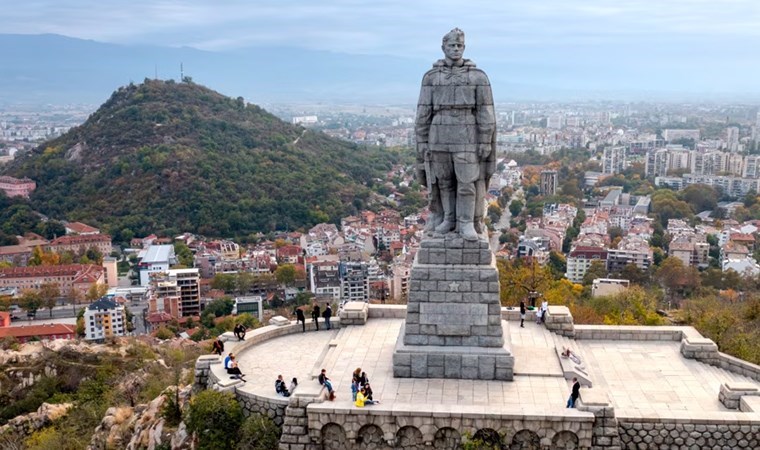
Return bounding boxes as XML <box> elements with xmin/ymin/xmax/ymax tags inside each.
<box><xmin>307</xmin><ymin>402</ymin><xmax>594</xmax><ymax>450</ymax></box>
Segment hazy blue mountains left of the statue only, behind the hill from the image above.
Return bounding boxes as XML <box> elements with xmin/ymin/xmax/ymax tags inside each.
<box><xmin>0</xmin><ymin>34</ymin><xmax>429</xmax><ymax>104</ymax></box>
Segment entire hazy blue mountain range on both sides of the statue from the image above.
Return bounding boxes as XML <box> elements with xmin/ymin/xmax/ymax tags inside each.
<box><xmin>0</xmin><ymin>34</ymin><xmax>760</xmax><ymax>105</ymax></box>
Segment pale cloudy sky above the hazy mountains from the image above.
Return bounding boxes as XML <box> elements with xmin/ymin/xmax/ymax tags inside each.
<box><xmin>0</xmin><ymin>0</ymin><xmax>760</xmax><ymax>93</ymax></box>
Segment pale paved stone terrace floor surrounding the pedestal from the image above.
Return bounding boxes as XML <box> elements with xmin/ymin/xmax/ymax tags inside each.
<box><xmin>239</xmin><ymin>319</ymin><xmax>752</xmax><ymax>412</ymax></box>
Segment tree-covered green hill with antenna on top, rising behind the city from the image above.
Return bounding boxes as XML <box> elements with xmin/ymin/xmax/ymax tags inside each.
<box><xmin>4</xmin><ymin>80</ymin><xmax>400</xmax><ymax>240</ymax></box>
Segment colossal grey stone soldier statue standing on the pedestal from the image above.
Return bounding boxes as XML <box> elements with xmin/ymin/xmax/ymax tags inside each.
<box><xmin>415</xmin><ymin>28</ymin><xmax>496</xmax><ymax>240</ymax></box>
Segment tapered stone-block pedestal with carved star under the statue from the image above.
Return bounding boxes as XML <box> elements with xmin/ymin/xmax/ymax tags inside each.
<box><xmin>393</xmin><ymin>237</ymin><xmax>514</xmax><ymax>380</ymax></box>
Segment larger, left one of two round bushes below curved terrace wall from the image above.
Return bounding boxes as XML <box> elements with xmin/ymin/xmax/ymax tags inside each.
<box><xmin>185</xmin><ymin>391</ymin><xmax>243</xmax><ymax>450</ymax></box>
